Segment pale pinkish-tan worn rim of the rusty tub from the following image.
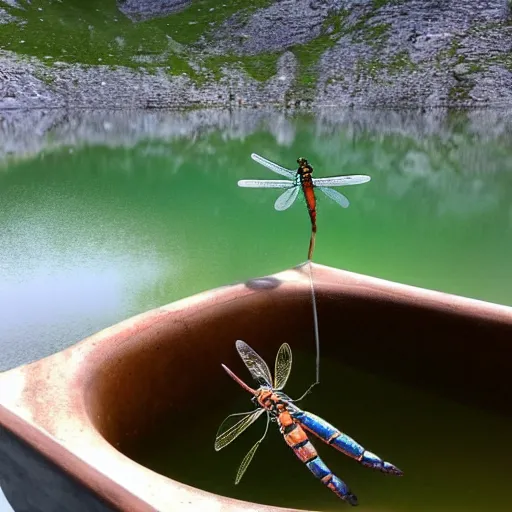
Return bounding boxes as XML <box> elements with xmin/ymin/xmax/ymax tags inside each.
<box><xmin>0</xmin><ymin>264</ymin><xmax>512</xmax><ymax>512</ymax></box>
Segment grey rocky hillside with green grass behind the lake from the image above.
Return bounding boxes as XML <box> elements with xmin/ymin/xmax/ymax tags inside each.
<box><xmin>0</xmin><ymin>0</ymin><xmax>512</xmax><ymax>109</ymax></box>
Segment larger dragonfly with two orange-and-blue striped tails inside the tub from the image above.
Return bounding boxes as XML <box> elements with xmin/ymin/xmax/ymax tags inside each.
<box><xmin>215</xmin><ymin>340</ymin><xmax>403</xmax><ymax>505</ymax></box>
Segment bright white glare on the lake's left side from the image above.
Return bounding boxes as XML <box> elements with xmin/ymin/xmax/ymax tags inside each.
<box><xmin>0</xmin><ymin>218</ymin><xmax>164</xmax><ymax>366</ymax></box>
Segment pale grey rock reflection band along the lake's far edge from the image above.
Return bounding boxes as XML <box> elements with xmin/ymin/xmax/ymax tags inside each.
<box><xmin>0</xmin><ymin>107</ymin><xmax>512</xmax><ymax>166</ymax></box>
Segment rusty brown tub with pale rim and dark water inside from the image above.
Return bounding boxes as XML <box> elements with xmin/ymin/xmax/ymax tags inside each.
<box><xmin>0</xmin><ymin>264</ymin><xmax>512</xmax><ymax>512</ymax></box>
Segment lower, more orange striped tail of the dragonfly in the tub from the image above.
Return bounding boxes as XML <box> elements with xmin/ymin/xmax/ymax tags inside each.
<box><xmin>278</xmin><ymin>410</ymin><xmax>357</xmax><ymax>505</ymax></box>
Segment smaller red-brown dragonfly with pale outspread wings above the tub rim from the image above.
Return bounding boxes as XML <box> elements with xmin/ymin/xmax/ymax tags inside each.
<box><xmin>238</xmin><ymin>153</ymin><xmax>371</xmax><ymax>260</ymax></box>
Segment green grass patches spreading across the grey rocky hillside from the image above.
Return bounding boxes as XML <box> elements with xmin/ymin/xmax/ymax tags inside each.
<box><xmin>0</xmin><ymin>0</ymin><xmax>512</xmax><ymax>93</ymax></box>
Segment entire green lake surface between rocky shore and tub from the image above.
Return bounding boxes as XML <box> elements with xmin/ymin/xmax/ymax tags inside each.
<box><xmin>0</xmin><ymin>110</ymin><xmax>512</xmax><ymax>369</ymax></box>
